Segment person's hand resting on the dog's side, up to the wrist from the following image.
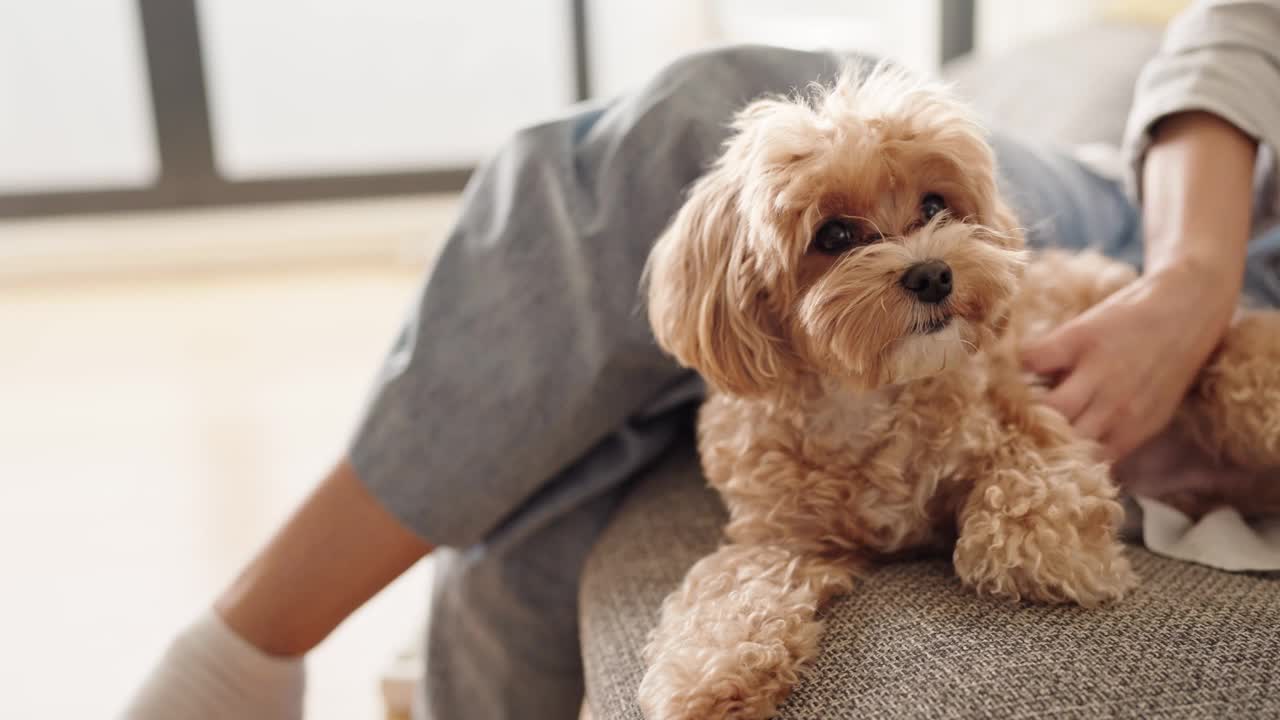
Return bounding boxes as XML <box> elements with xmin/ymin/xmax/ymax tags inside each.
<box><xmin>1023</xmin><ymin>258</ymin><xmax>1239</xmax><ymax>460</ymax></box>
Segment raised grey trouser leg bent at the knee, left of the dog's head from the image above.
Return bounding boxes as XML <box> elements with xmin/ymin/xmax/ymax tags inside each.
<box><xmin>351</xmin><ymin>47</ymin><xmax>838</xmax><ymax>547</ymax></box>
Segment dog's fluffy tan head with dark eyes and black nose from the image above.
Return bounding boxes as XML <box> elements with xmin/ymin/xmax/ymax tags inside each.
<box><xmin>648</xmin><ymin>67</ymin><xmax>1023</xmax><ymax>395</ymax></box>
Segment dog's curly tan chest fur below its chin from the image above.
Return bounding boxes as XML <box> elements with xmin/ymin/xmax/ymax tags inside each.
<box><xmin>700</xmin><ymin>368</ymin><xmax>986</xmax><ymax>552</ymax></box>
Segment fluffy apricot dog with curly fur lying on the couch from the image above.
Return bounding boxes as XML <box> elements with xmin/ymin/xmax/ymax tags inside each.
<box><xmin>640</xmin><ymin>68</ymin><xmax>1280</xmax><ymax>720</ymax></box>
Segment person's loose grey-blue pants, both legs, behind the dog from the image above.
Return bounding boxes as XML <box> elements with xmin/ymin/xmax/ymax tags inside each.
<box><xmin>349</xmin><ymin>47</ymin><xmax>1280</xmax><ymax>720</ymax></box>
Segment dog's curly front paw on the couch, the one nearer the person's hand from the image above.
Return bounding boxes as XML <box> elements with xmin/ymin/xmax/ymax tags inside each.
<box><xmin>954</xmin><ymin>466</ymin><xmax>1137</xmax><ymax>607</ymax></box>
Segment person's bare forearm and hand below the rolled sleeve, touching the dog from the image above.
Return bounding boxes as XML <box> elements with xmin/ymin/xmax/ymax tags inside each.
<box><xmin>1024</xmin><ymin>111</ymin><xmax>1257</xmax><ymax>459</ymax></box>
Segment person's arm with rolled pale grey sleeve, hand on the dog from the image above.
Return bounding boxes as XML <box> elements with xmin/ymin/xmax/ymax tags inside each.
<box><xmin>1024</xmin><ymin>0</ymin><xmax>1280</xmax><ymax>459</ymax></box>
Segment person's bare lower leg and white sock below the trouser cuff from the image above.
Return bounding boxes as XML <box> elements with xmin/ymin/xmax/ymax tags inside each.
<box><xmin>123</xmin><ymin>461</ymin><xmax>431</xmax><ymax>720</ymax></box>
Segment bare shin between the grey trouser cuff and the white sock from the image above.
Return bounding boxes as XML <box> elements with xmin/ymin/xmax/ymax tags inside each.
<box><xmin>214</xmin><ymin>460</ymin><xmax>431</xmax><ymax>656</ymax></box>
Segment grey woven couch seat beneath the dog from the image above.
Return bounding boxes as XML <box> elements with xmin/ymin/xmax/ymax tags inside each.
<box><xmin>581</xmin><ymin>447</ymin><xmax>1280</xmax><ymax>720</ymax></box>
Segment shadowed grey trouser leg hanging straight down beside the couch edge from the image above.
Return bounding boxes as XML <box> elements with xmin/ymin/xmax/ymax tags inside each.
<box><xmin>415</xmin><ymin>412</ymin><xmax>696</xmax><ymax>720</ymax></box>
